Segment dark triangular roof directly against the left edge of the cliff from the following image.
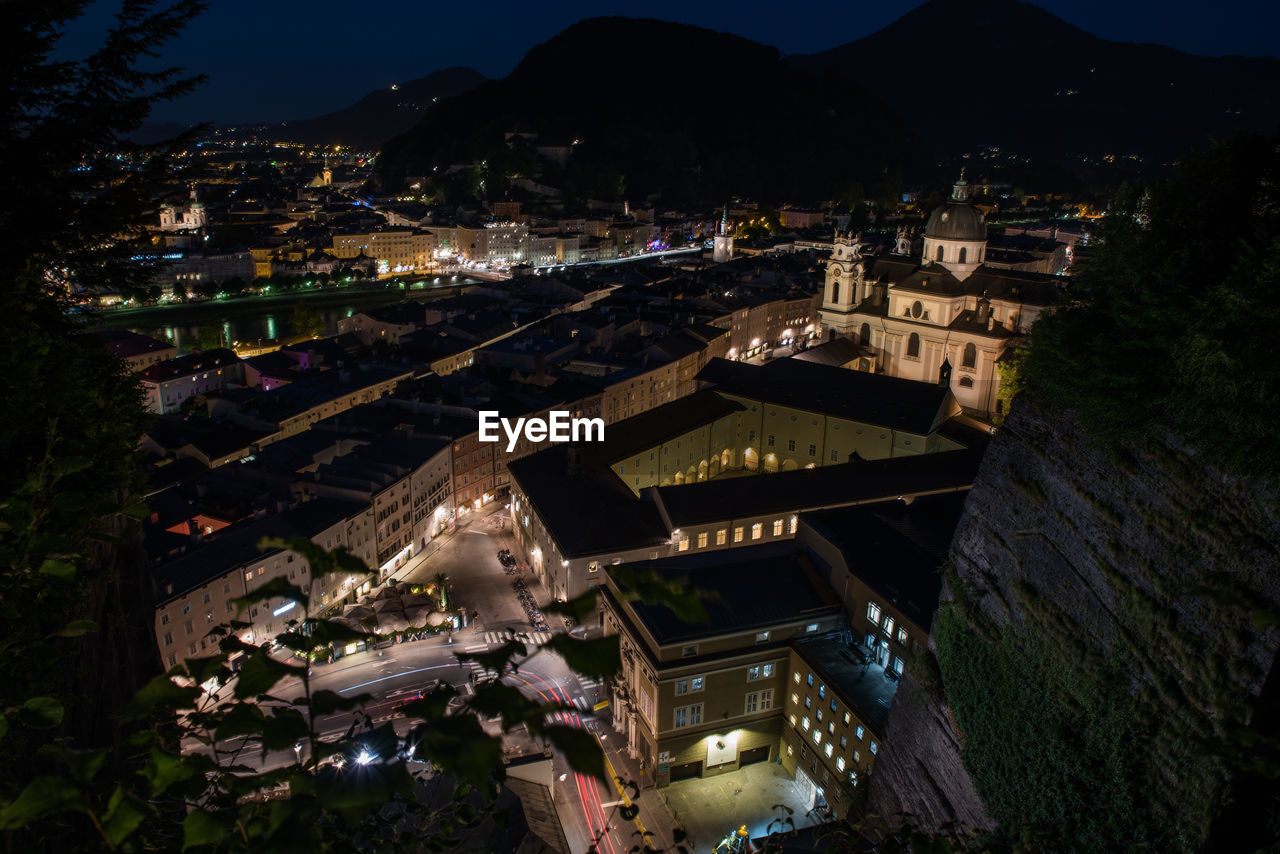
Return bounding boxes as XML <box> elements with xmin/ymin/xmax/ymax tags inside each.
<box><xmin>803</xmin><ymin>493</ymin><xmax>965</xmax><ymax>631</ymax></box>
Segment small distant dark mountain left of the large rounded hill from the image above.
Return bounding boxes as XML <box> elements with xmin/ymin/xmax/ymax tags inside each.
<box><xmin>273</xmin><ymin>68</ymin><xmax>486</xmax><ymax>149</ymax></box>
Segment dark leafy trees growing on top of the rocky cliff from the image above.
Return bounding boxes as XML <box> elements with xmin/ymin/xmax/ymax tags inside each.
<box><xmin>1023</xmin><ymin>134</ymin><xmax>1280</xmax><ymax>479</ymax></box>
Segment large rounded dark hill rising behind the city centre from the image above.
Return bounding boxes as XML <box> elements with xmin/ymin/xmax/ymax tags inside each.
<box><xmin>378</xmin><ymin>18</ymin><xmax>911</xmax><ymax>204</ymax></box>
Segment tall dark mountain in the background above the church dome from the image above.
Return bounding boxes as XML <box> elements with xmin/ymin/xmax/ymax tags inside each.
<box><xmin>788</xmin><ymin>0</ymin><xmax>1280</xmax><ymax>163</ymax></box>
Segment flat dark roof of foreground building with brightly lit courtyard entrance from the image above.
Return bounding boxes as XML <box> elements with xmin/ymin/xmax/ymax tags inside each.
<box><xmin>605</xmin><ymin>542</ymin><xmax>840</xmax><ymax>645</ymax></box>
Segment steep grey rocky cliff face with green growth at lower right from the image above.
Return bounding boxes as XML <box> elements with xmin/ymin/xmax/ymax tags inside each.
<box><xmin>869</xmin><ymin>396</ymin><xmax>1280</xmax><ymax>850</ymax></box>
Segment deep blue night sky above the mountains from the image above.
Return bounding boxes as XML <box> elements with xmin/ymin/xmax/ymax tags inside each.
<box><xmin>64</xmin><ymin>0</ymin><xmax>1280</xmax><ymax>123</ymax></box>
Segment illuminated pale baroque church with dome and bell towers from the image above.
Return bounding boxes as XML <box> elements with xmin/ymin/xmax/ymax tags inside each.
<box><xmin>819</xmin><ymin>173</ymin><xmax>1068</xmax><ymax>419</ymax></box>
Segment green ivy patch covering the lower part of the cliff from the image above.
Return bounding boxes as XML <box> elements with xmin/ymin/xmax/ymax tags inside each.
<box><xmin>936</xmin><ymin>606</ymin><xmax>1162</xmax><ymax>851</ymax></box>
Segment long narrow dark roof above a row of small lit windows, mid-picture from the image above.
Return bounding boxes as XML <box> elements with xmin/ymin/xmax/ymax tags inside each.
<box><xmin>655</xmin><ymin>449</ymin><xmax>982</xmax><ymax>529</ymax></box>
